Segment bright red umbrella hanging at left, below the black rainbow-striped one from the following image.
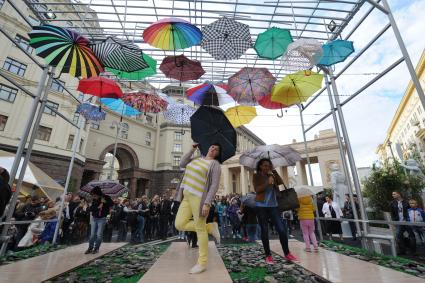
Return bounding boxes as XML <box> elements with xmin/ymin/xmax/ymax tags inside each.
<box><xmin>77</xmin><ymin>77</ymin><xmax>124</xmax><ymax>98</ymax></box>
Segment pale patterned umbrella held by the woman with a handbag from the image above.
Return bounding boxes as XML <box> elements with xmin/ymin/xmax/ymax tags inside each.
<box><xmin>239</xmin><ymin>144</ymin><xmax>301</xmax><ymax>169</ymax></box>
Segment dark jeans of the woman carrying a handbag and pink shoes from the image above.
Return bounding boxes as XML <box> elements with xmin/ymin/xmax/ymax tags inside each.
<box><xmin>257</xmin><ymin>207</ymin><xmax>289</xmax><ymax>256</ymax></box>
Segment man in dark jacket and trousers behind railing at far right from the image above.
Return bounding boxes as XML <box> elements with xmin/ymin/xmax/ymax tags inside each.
<box><xmin>391</xmin><ymin>191</ymin><xmax>416</xmax><ymax>254</ymax></box>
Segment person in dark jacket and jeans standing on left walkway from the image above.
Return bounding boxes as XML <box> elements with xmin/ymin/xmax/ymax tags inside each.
<box><xmin>85</xmin><ymin>187</ymin><xmax>113</xmax><ymax>254</ymax></box>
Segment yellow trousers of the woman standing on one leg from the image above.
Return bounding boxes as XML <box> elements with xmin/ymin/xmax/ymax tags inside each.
<box><xmin>175</xmin><ymin>191</ymin><xmax>212</xmax><ymax>266</ymax></box>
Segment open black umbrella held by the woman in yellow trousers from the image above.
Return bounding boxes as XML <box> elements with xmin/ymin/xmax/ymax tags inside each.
<box><xmin>190</xmin><ymin>106</ymin><xmax>236</xmax><ymax>162</ymax></box>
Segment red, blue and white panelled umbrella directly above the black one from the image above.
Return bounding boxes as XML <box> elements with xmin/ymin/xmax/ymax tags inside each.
<box><xmin>186</xmin><ymin>82</ymin><xmax>235</xmax><ymax>106</ymax></box>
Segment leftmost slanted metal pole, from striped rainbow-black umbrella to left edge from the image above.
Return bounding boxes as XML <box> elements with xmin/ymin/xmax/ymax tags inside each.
<box><xmin>0</xmin><ymin>68</ymin><xmax>53</xmax><ymax>256</ymax></box>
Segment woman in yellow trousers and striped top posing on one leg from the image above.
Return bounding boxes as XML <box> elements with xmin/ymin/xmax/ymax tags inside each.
<box><xmin>175</xmin><ymin>144</ymin><xmax>221</xmax><ymax>274</ymax></box>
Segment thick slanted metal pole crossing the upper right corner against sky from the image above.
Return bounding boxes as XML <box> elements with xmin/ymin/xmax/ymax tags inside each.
<box><xmin>382</xmin><ymin>0</ymin><xmax>425</xmax><ymax>111</ymax></box>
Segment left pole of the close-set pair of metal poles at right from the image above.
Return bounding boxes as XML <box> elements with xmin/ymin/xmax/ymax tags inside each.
<box><xmin>325</xmin><ymin>73</ymin><xmax>366</xmax><ymax>242</ymax></box>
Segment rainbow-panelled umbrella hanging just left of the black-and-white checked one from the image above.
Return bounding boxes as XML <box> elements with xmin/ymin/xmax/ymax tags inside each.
<box><xmin>143</xmin><ymin>18</ymin><xmax>202</xmax><ymax>50</ymax></box>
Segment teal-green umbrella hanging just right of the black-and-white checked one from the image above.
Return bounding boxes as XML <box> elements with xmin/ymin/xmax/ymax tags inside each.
<box><xmin>254</xmin><ymin>27</ymin><xmax>294</xmax><ymax>60</ymax></box>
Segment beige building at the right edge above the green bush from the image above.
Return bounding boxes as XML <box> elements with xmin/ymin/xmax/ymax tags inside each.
<box><xmin>376</xmin><ymin>50</ymin><xmax>425</xmax><ymax>161</ymax></box>
